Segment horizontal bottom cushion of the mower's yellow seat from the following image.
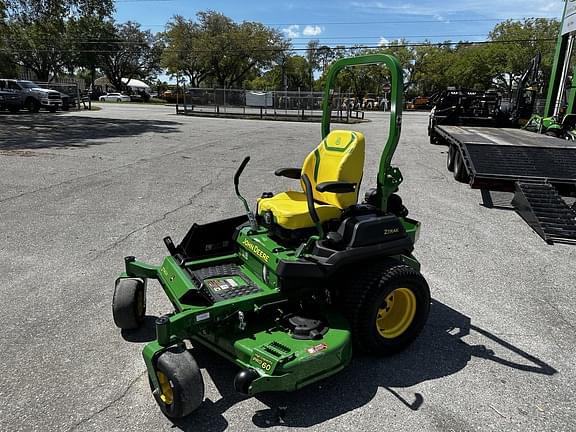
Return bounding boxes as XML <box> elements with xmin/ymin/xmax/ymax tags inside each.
<box><xmin>258</xmin><ymin>191</ymin><xmax>342</xmax><ymax>229</ymax></box>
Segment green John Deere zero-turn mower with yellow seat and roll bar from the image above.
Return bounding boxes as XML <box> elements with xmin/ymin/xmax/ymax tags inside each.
<box><xmin>112</xmin><ymin>54</ymin><xmax>430</xmax><ymax>418</ymax></box>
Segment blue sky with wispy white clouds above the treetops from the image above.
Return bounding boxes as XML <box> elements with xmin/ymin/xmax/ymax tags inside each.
<box><xmin>116</xmin><ymin>0</ymin><xmax>564</xmax><ymax>48</ymax></box>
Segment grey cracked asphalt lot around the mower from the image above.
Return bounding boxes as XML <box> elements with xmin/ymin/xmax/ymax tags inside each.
<box><xmin>0</xmin><ymin>104</ymin><xmax>576</xmax><ymax>431</ymax></box>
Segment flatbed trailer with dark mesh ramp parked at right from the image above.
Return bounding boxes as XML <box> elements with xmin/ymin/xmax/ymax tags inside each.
<box><xmin>433</xmin><ymin>125</ymin><xmax>576</xmax><ymax>244</ymax></box>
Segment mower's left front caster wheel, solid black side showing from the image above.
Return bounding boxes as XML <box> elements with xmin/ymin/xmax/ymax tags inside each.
<box><xmin>112</xmin><ymin>279</ymin><xmax>146</xmax><ymax>330</ymax></box>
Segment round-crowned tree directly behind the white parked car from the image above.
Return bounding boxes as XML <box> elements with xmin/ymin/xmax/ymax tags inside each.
<box><xmin>102</xmin><ymin>21</ymin><xmax>164</xmax><ymax>90</ymax></box>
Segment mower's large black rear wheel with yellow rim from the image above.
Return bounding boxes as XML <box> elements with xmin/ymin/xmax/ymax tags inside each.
<box><xmin>340</xmin><ymin>259</ymin><xmax>430</xmax><ymax>356</ymax></box>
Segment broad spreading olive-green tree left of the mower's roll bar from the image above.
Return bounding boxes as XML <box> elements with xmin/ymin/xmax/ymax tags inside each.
<box><xmin>194</xmin><ymin>11</ymin><xmax>289</xmax><ymax>87</ymax></box>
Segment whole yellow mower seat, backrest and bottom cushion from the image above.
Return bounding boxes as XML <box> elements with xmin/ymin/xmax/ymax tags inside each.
<box><xmin>258</xmin><ymin>130</ymin><xmax>364</xmax><ymax>230</ymax></box>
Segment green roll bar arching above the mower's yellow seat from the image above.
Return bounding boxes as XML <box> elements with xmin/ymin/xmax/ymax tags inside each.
<box><xmin>322</xmin><ymin>54</ymin><xmax>404</xmax><ymax>210</ymax></box>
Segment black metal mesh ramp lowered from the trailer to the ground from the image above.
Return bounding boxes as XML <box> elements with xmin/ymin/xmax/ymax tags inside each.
<box><xmin>512</xmin><ymin>182</ymin><xmax>576</xmax><ymax>244</ymax></box>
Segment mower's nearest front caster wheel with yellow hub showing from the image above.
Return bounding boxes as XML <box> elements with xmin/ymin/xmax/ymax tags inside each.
<box><xmin>150</xmin><ymin>347</ymin><xmax>204</xmax><ymax>418</ymax></box>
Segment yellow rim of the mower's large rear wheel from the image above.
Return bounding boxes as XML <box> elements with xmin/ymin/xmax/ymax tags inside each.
<box><xmin>376</xmin><ymin>288</ymin><xmax>416</xmax><ymax>339</ymax></box>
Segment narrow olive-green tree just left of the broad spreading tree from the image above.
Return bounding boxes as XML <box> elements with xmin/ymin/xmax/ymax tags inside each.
<box><xmin>161</xmin><ymin>15</ymin><xmax>211</xmax><ymax>87</ymax></box>
